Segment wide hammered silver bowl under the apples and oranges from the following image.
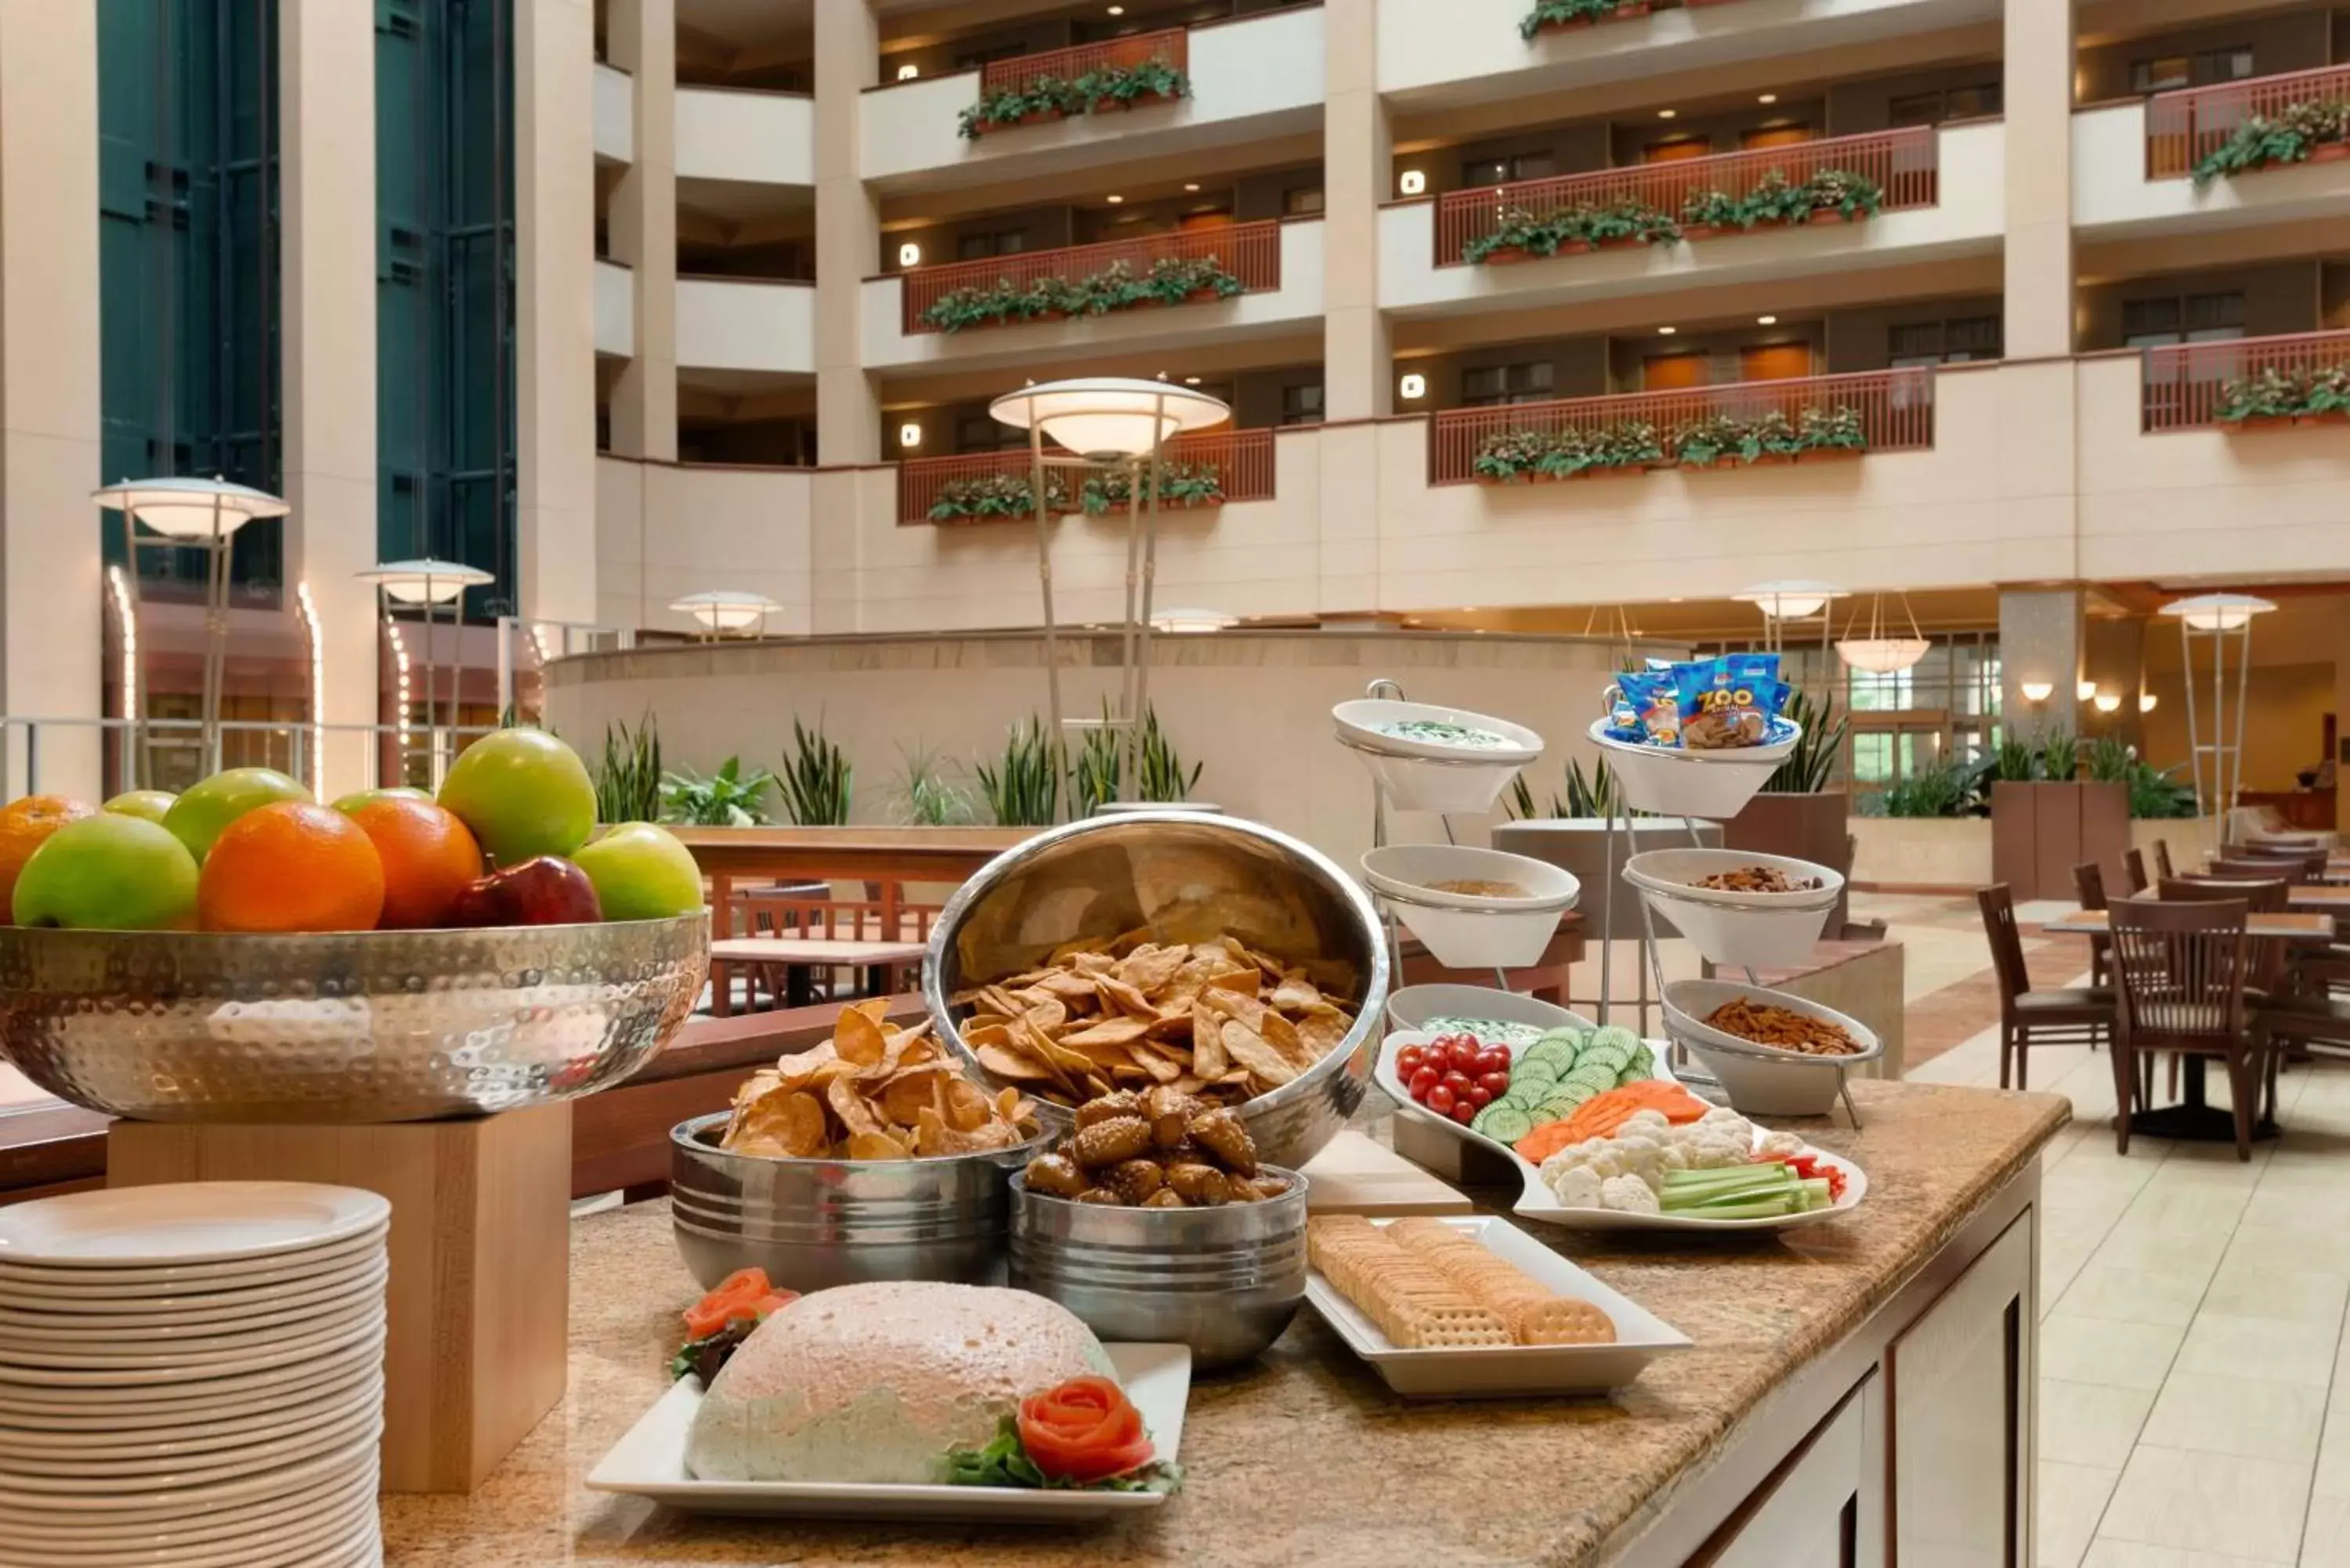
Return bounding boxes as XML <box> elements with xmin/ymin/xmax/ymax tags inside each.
<box><xmin>0</xmin><ymin>915</ymin><xmax>710</xmax><ymax>1124</ymax></box>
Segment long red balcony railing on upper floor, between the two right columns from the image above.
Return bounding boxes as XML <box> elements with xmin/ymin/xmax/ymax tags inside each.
<box><xmin>1436</xmin><ymin>125</ymin><xmax>1941</xmax><ymax>266</ymax></box>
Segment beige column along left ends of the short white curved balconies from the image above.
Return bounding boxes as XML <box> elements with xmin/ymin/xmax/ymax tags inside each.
<box><xmin>606</xmin><ymin>0</ymin><xmax>677</xmax><ymax>461</ymax></box>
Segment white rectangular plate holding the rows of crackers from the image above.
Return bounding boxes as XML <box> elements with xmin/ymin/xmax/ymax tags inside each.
<box><xmin>1307</xmin><ymin>1216</ymin><xmax>1690</xmax><ymax>1399</ymax></box>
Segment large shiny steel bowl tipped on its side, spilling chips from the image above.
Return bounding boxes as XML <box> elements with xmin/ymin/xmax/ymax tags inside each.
<box><xmin>921</xmin><ymin>811</ymin><xmax>1389</xmax><ymax>1166</ymax></box>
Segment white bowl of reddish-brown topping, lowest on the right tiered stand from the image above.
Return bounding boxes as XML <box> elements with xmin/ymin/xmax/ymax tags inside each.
<box><xmin>1664</xmin><ymin>981</ymin><xmax>1885</xmax><ymax>1117</ymax></box>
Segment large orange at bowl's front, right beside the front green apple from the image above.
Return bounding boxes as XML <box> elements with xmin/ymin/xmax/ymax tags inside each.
<box><xmin>195</xmin><ymin>800</ymin><xmax>383</xmax><ymax>931</ymax></box>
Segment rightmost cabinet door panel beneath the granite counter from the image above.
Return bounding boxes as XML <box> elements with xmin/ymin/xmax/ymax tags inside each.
<box><xmin>1885</xmin><ymin>1211</ymin><xmax>2037</xmax><ymax>1568</ymax></box>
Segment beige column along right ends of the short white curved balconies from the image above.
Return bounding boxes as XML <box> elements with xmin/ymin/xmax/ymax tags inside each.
<box><xmin>815</xmin><ymin>0</ymin><xmax>881</xmax><ymax>463</ymax></box>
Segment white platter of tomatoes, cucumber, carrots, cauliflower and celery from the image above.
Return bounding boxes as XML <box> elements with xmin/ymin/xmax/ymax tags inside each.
<box><xmin>1372</xmin><ymin>1028</ymin><xmax>1868</xmax><ymax>1232</ymax></box>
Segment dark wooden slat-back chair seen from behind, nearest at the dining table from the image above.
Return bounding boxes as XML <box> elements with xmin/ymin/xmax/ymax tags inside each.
<box><xmin>2110</xmin><ymin>898</ymin><xmax>2265</xmax><ymax>1164</ymax></box>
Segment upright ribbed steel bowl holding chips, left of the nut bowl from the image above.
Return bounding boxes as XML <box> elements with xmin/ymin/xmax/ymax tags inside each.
<box><xmin>670</xmin><ymin>1112</ymin><xmax>1050</xmax><ymax>1291</ymax></box>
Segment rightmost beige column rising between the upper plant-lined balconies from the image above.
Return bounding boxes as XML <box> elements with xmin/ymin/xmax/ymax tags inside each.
<box><xmin>2005</xmin><ymin>0</ymin><xmax>2075</xmax><ymax>359</ymax></box>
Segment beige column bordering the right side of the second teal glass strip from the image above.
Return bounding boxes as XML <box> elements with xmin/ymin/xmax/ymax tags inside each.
<box><xmin>515</xmin><ymin>0</ymin><xmax>597</xmax><ymax>620</ymax></box>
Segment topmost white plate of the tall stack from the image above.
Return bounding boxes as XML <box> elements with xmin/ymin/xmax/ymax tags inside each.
<box><xmin>0</xmin><ymin>1183</ymin><xmax>392</xmax><ymax>1270</ymax></box>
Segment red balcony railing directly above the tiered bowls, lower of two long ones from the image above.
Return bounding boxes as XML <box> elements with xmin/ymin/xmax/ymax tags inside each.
<box><xmin>1429</xmin><ymin>369</ymin><xmax>1934</xmax><ymax>484</ymax></box>
